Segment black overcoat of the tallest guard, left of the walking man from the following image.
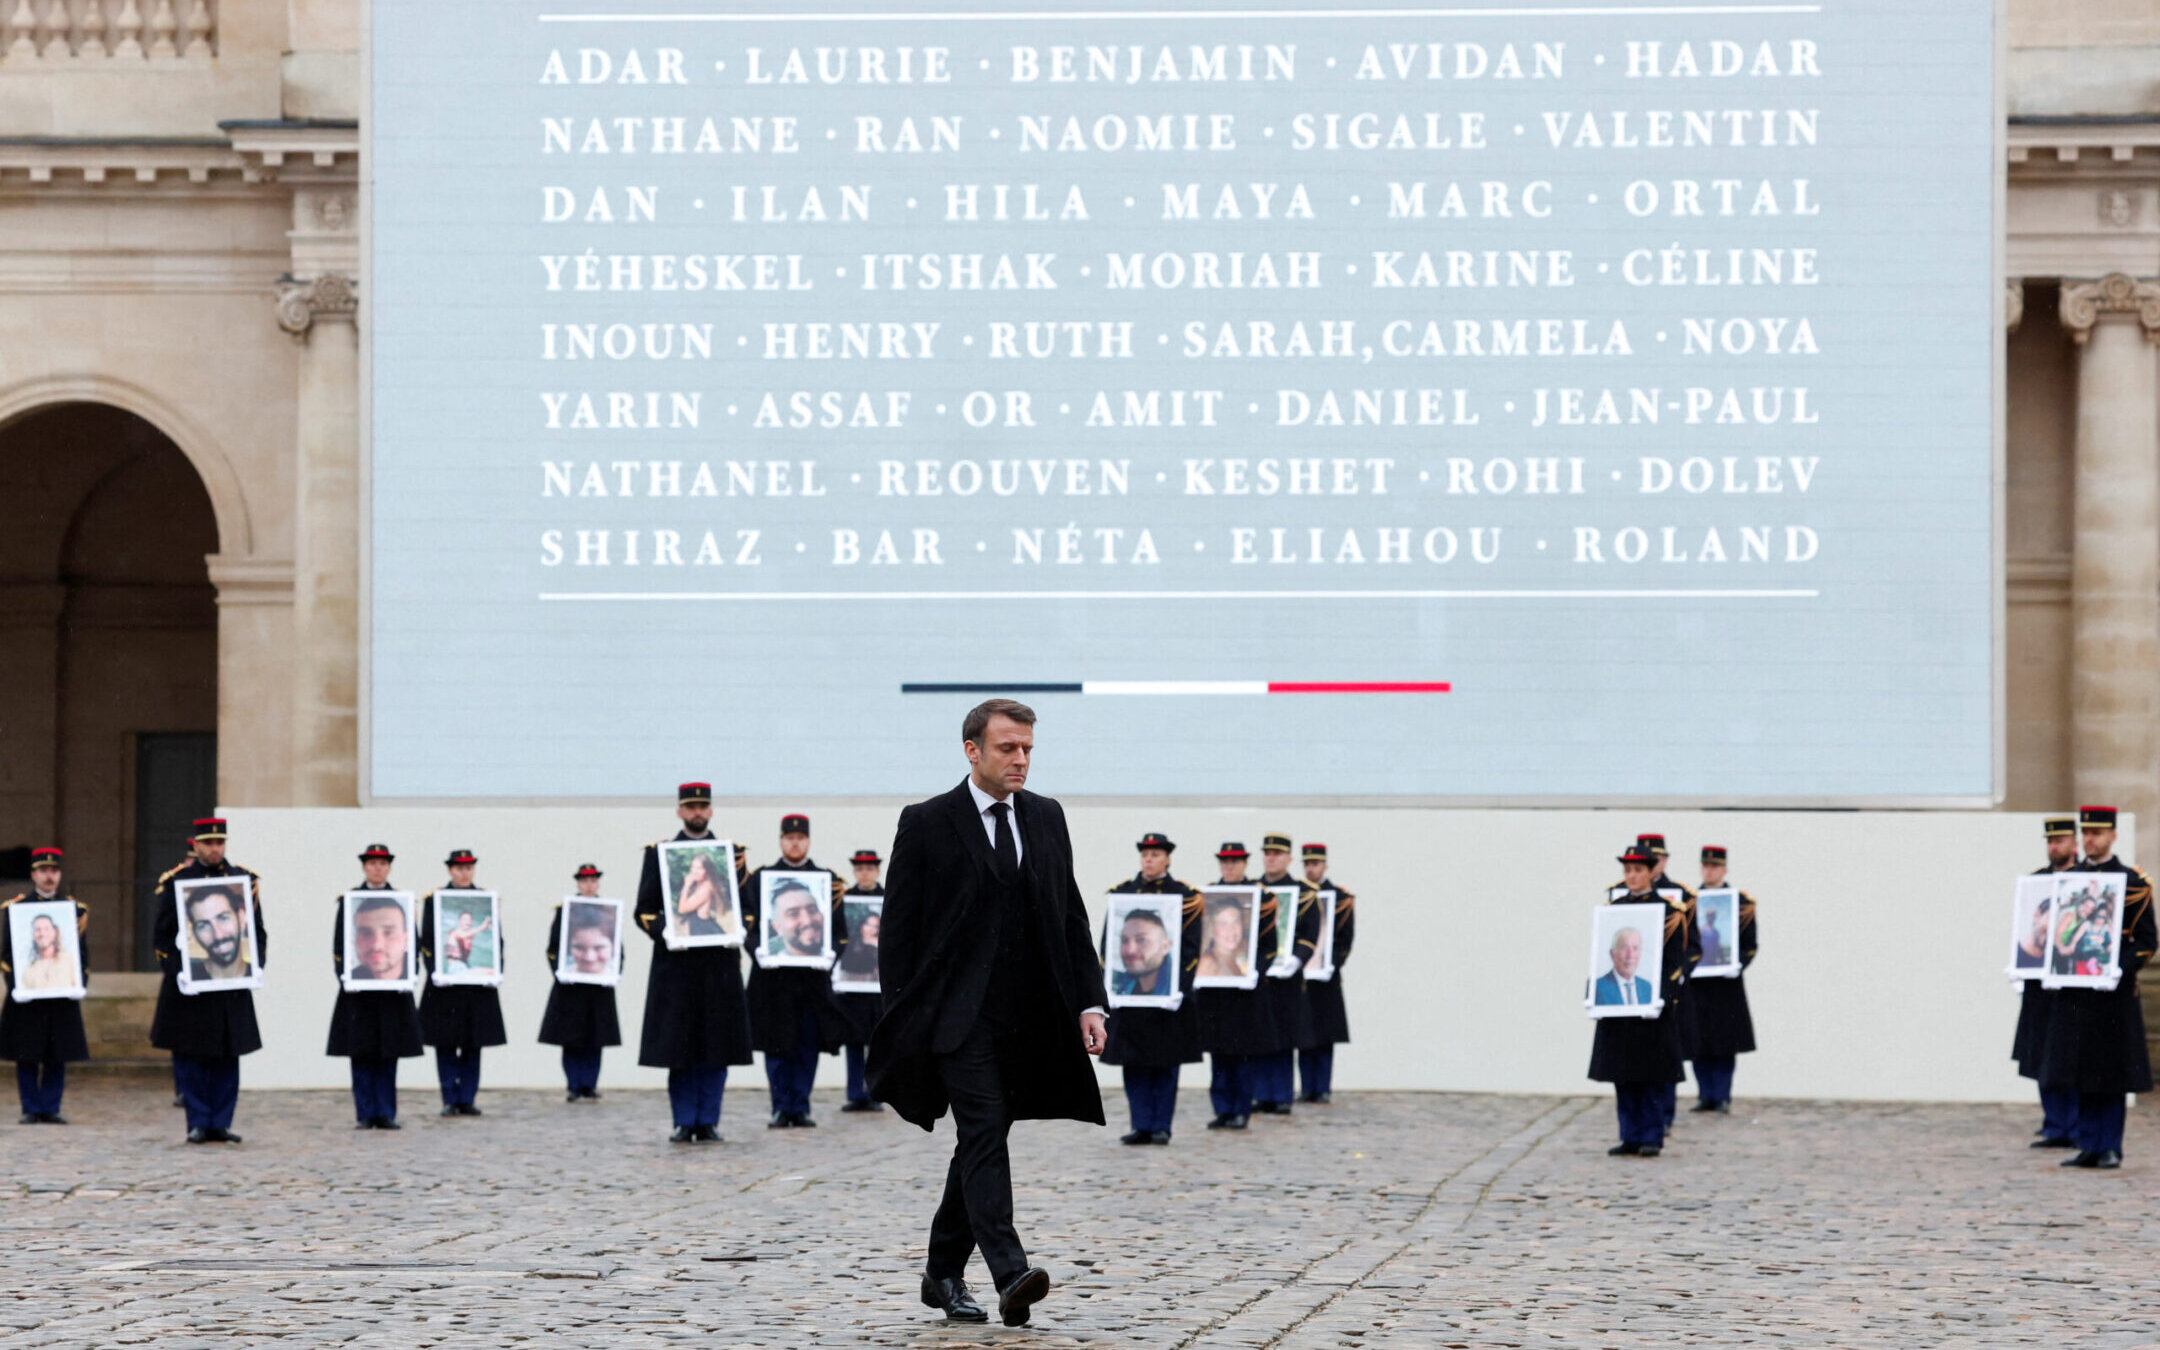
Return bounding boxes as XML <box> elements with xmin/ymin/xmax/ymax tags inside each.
<box><xmin>633</xmin><ymin>829</ymin><xmax>750</xmax><ymax>1069</ymax></box>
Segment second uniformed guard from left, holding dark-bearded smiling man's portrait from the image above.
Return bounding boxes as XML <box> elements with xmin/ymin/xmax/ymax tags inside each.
<box><xmin>149</xmin><ymin>816</ymin><xmax>270</xmax><ymax>1145</ymax></box>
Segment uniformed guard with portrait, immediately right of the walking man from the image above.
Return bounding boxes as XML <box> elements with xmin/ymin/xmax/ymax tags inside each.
<box><xmin>1102</xmin><ymin>832</ymin><xmax>1205</xmax><ymax>1145</ymax></box>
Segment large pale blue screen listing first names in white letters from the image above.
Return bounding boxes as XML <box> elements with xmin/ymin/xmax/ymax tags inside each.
<box><xmin>365</xmin><ymin>0</ymin><xmax>2000</xmax><ymax>801</ymax></box>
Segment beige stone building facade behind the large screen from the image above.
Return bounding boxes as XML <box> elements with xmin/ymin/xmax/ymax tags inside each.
<box><xmin>0</xmin><ymin>0</ymin><xmax>2160</xmax><ymax>970</ymax></box>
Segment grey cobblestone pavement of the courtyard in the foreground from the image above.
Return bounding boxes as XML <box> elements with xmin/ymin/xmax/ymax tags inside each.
<box><xmin>0</xmin><ymin>1076</ymin><xmax>2160</xmax><ymax>1350</ymax></box>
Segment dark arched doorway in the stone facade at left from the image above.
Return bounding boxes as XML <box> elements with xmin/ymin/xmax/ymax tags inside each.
<box><xmin>0</xmin><ymin>404</ymin><xmax>218</xmax><ymax>970</ymax></box>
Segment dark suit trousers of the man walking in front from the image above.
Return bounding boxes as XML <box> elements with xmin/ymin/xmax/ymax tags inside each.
<box><xmin>929</xmin><ymin>1022</ymin><xmax>1028</xmax><ymax>1290</ymax></box>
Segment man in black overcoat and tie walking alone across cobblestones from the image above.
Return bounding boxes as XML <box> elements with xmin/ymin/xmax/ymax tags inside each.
<box><xmin>870</xmin><ymin>698</ymin><xmax>1108</xmax><ymax>1326</ymax></box>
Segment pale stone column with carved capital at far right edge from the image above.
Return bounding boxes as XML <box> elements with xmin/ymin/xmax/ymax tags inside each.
<box><xmin>2061</xmin><ymin>272</ymin><xmax>2160</xmax><ymax>866</ymax></box>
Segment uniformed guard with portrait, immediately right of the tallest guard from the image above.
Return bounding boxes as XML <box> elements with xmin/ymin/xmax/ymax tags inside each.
<box><xmin>743</xmin><ymin>814</ymin><xmax>847</xmax><ymax>1130</ymax></box>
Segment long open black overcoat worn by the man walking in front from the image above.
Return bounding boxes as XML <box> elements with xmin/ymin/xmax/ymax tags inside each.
<box><xmin>868</xmin><ymin>782</ymin><xmax>1108</xmax><ymax>1130</ymax></box>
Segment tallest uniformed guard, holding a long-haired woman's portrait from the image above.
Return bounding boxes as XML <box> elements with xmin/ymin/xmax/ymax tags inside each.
<box><xmin>637</xmin><ymin>782</ymin><xmax>750</xmax><ymax>1145</ymax></box>
